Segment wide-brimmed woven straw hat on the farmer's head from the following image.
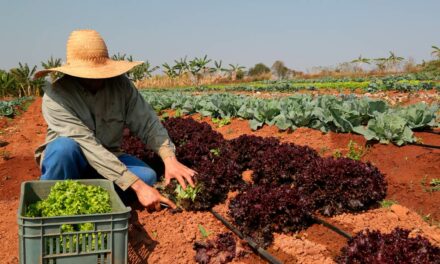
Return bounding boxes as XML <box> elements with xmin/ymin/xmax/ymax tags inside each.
<box><xmin>35</xmin><ymin>30</ymin><xmax>143</xmax><ymax>79</ymax></box>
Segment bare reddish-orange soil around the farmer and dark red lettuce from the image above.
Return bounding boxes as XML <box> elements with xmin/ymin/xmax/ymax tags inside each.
<box><xmin>0</xmin><ymin>99</ymin><xmax>440</xmax><ymax>263</ymax></box>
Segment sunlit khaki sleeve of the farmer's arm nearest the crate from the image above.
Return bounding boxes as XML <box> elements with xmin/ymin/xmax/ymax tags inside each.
<box><xmin>42</xmin><ymin>94</ymin><xmax>138</xmax><ymax>190</ymax></box>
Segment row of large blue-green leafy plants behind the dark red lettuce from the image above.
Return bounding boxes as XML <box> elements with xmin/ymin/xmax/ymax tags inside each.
<box><xmin>142</xmin><ymin>91</ymin><xmax>440</xmax><ymax>146</ymax></box>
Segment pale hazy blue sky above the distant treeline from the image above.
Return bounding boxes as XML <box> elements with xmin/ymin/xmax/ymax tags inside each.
<box><xmin>0</xmin><ymin>0</ymin><xmax>440</xmax><ymax>70</ymax></box>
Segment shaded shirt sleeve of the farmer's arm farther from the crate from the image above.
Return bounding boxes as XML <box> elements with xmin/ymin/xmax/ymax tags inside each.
<box><xmin>125</xmin><ymin>79</ymin><xmax>175</xmax><ymax>160</ymax></box>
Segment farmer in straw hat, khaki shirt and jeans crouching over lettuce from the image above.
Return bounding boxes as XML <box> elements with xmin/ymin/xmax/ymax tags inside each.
<box><xmin>35</xmin><ymin>30</ymin><xmax>195</xmax><ymax>210</ymax></box>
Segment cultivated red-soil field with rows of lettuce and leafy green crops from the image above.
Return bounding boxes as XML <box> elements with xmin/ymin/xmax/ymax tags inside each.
<box><xmin>0</xmin><ymin>77</ymin><xmax>440</xmax><ymax>263</ymax></box>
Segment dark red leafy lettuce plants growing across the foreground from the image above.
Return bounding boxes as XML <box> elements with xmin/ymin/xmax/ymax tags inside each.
<box><xmin>122</xmin><ymin>118</ymin><xmax>440</xmax><ymax>263</ymax></box>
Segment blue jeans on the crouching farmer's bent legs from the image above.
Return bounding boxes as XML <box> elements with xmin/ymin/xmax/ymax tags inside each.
<box><xmin>40</xmin><ymin>137</ymin><xmax>157</xmax><ymax>186</ymax></box>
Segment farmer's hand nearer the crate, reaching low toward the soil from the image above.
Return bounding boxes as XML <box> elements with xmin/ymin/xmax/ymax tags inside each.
<box><xmin>131</xmin><ymin>179</ymin><xmax>176</xmax><ymax>211</ymax></box>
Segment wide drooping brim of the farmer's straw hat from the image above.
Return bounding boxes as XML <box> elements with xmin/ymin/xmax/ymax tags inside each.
<box><xmin>35</xmin><ymin>59</ymin><xmax>144</xmax><ymax>79</ymax></box>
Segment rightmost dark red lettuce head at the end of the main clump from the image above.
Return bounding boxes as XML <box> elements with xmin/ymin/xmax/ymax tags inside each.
<box><xmin>295</xmin><ymin>158</ymin><xmax>387</xmax><ymax>216</ymax></box>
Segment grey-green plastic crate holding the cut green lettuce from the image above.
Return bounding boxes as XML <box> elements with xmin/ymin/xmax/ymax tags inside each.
<box><xmin>18</xmin><ymin>180</ymin><xmax>131</xmax><ymax>264</ymax></box>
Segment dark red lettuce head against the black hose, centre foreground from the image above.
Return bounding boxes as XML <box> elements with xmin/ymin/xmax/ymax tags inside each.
<box><xmin>228</xmin><ymin>185</ymin><xmax>312</xmax><ymax>247</ymax></box>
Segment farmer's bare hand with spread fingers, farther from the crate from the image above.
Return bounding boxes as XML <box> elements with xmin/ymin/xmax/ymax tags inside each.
<box><xmin>163</xmin><ymin>157</ymin><xmax>197</xmax><ymax>189</ymax></box>
